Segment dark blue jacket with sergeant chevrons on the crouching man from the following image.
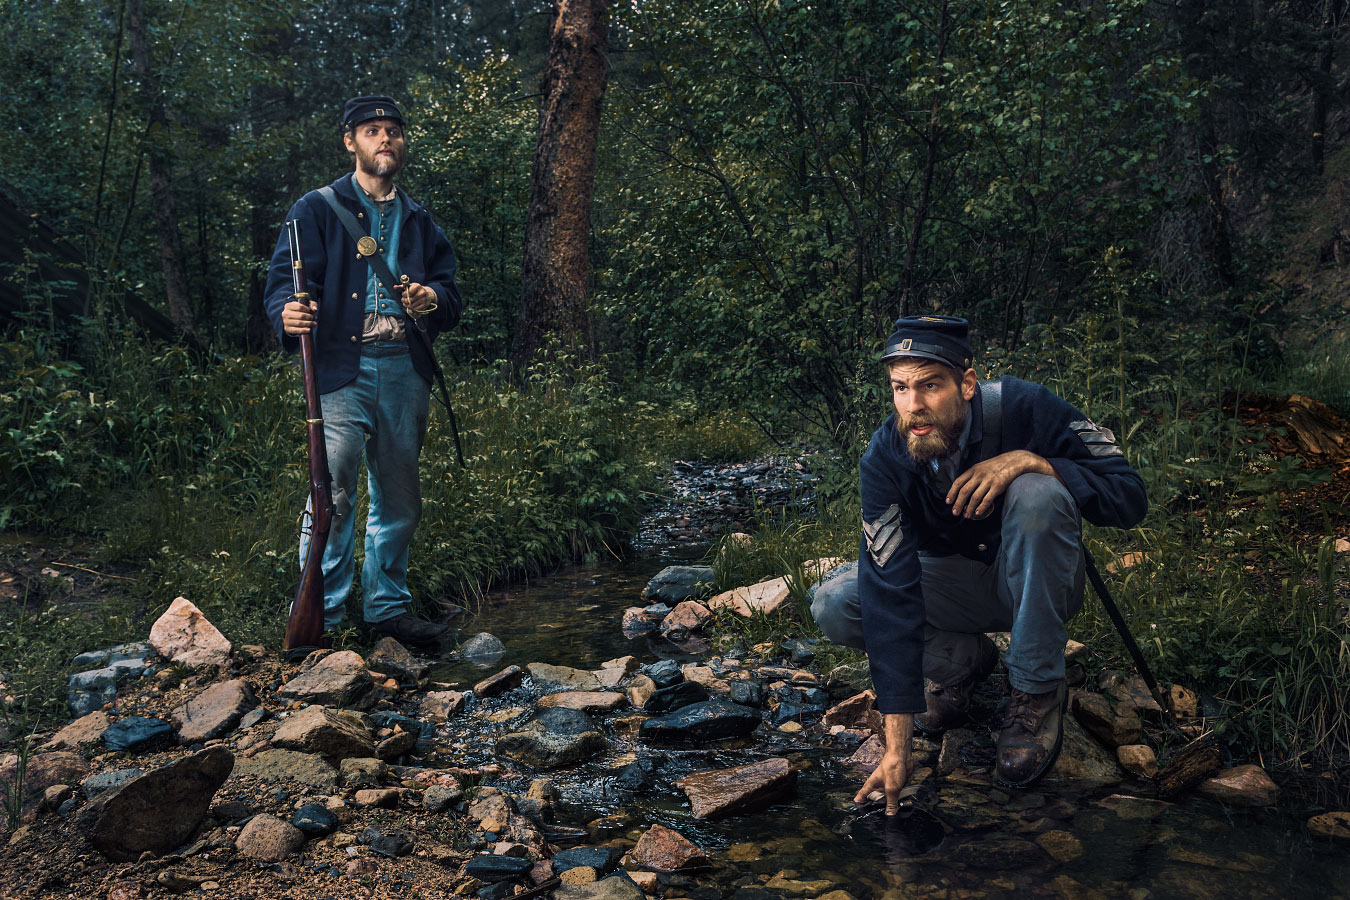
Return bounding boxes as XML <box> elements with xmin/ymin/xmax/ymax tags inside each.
<box><xmin>857</xmin><ymin>378</ymin><xmax>1148</xmax><ymax>712</ymax></box>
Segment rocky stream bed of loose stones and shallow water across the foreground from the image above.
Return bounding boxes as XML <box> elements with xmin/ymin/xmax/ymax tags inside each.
<box><xmin>0</xmin><ymin>456</ymin><xmax>1350</xmax><ymax>900</ymax></box>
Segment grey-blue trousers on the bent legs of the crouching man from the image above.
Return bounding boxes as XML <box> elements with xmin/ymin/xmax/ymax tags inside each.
<box><xmin>809</xmin><ymin>475</ymin><xmax>1084</xmax><ymax>694</ymax></box>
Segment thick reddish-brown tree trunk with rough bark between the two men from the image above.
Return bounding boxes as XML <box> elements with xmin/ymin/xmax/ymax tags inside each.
<box><xmin>510</xmin><ymin>0</ymin><xmax>609</xmax><ymax>367</ymax></box>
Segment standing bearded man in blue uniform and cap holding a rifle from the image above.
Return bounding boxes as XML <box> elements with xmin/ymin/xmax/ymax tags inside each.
<box><xmin>266</xmin><ymin>97</ymin><xmax>462</xmax><ymax>646</ymax></box>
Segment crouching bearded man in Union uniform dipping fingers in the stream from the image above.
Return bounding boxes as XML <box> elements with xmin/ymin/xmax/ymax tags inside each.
<box><xmin>811</xmin><ymin>316</ymin><xmax>1148</xmax><ymax>812</ymax></box>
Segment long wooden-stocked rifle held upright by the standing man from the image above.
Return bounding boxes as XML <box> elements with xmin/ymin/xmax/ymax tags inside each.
<box><xmin>282</xmin><ymin>219</ymin><xmax>333</xmax><ymax>663</ymax></box>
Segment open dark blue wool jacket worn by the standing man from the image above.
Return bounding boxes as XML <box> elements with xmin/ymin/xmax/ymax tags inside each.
<box><xmin>263</xmin><ymin>174</ymin><xmax>463</xmax><ymax>394</ymax></box>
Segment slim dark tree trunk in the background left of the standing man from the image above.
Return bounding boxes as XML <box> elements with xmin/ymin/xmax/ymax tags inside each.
<box><xmin>127</xmin><ymin>0</ymin><xmax>196</xmax><ymax>335</ymax></box>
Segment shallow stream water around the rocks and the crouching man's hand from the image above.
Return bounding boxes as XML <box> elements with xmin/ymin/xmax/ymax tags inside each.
<box><xmin>423</xmin><ymin>461</ymin><xmax>1350</xmax><ymax>900</ymax></box>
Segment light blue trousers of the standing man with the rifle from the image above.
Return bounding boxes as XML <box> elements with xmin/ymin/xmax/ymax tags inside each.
<box><xmin>300</xmin><ymin>341</ymin><xmax>431</xmax><ymax>629</ymax></box>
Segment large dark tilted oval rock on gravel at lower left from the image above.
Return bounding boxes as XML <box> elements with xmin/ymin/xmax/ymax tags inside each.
<box><xmin>80</xmin><ymin>748</ymin><xmax>235</xmax><ymax>861</ymax></box>
